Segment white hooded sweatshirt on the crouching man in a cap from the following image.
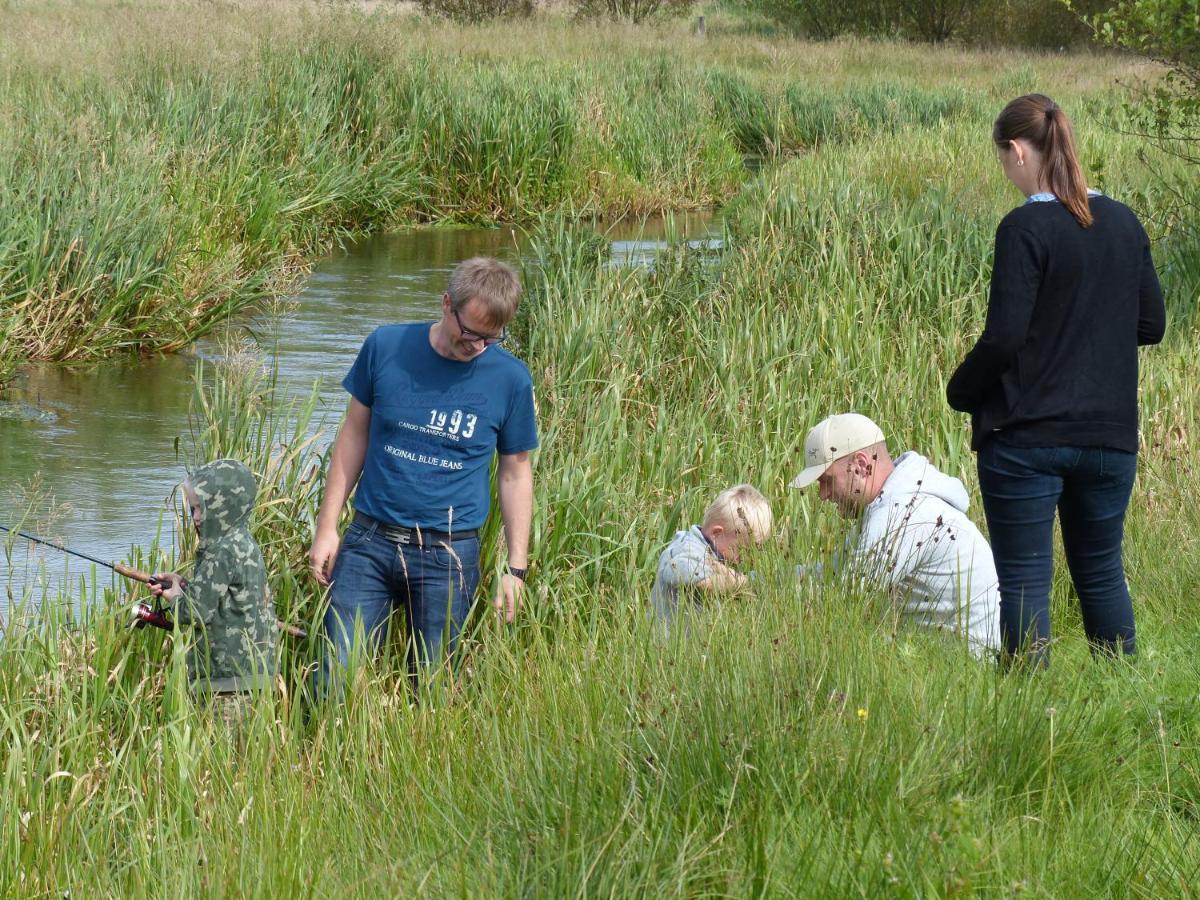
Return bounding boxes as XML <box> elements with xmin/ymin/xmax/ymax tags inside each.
<box><xmin>851</xmin><ymin>450</ymin><xmax>1000</xmax><ymax>655</ymax></box>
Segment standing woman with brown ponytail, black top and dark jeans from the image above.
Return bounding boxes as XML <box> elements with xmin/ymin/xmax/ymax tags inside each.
<box><xmin>947</xmin><ymin>94</ymin><xmax>1166</xmax><ymax>665</ymax></box>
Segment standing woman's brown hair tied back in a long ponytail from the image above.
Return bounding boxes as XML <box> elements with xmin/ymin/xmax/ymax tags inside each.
<box><xmin>991</xmin><ymin>94</ymin><xmax>1092</xmax><ymax>228</ymax></box>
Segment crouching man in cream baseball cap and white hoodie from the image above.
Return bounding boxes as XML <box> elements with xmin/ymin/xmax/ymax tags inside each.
<box><xmin>792</xmin><ymin>413</ymin><xmax>1000</xmax><ymax>656</ymax></box>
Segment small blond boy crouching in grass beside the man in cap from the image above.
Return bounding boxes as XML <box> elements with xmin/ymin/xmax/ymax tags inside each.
<box><xmin>650</xmin><ymin>485</ymin><xmax>772</xmax><ymax>625</ymax></box>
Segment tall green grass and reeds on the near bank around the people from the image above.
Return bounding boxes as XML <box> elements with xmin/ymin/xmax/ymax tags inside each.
<box><xmin>0</xmin><ymin>3</ymin><xmax>1200</xmax><ymax>896</ymax></box>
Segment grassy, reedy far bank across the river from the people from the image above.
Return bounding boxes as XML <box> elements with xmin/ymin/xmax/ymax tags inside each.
<box><xmin>0</xmin><ymin>4</ymin><xmax>1156</xmax><ymax>383</ymax></box>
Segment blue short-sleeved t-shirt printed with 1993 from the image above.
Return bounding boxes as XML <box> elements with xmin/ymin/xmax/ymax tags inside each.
<box><xmin>342</xmin><ymin>322</ymin><xmax>538</xmax><ymax>532</ymax></box>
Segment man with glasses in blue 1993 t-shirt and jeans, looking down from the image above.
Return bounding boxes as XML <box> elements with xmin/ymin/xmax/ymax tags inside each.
<box><xmin>308</xmin><ymin>257</ymin><xmax>538</xmax><ymax>678</ymax></box>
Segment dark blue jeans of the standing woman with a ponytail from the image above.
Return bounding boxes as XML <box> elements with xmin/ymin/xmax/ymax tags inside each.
<box><xmin>978</xmin><ymin>439</ymin><xmax>1138</xmax><ymax>665</ymax></box>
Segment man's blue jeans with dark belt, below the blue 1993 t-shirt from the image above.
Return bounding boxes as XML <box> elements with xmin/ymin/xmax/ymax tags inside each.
<box><xmin>318</xmin><ymin>522</ymin><xmax>479</xmax><ymax>694</ymax></box>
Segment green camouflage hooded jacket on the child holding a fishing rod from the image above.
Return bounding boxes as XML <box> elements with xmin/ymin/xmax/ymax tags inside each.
<box><xmin>173</xmin><ymin>460</ymin><xmax>280</xmax><ymax>692</ymax></box>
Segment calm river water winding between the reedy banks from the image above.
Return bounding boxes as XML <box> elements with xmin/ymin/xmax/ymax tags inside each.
<box><xmin>0</xmin><ymin>216</ymin><xmax>714</xmax><ymax>629</ymax></box>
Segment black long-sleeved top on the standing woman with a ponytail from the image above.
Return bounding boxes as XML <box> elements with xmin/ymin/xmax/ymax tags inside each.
<box><xmin>946</xmin><ymin>194</ymin><xmax>1166</xmax><ymax>452</ymax></box>
